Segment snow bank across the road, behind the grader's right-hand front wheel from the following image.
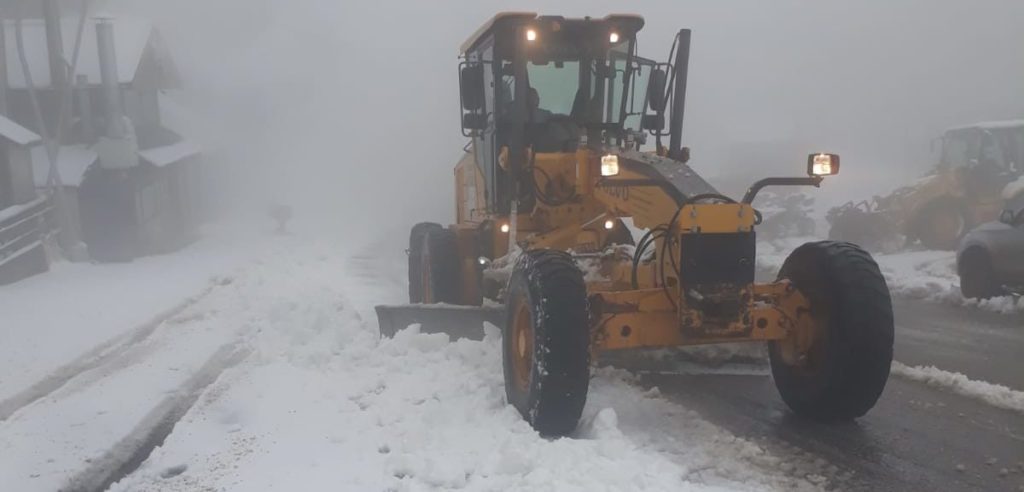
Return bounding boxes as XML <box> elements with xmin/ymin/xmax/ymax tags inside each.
<box><xmin>758</xmin><ymin>238</ymin><xmax>1024</xmax><ymax>315</ymax></box>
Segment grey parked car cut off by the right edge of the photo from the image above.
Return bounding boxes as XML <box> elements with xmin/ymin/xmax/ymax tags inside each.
<box><xmin>956</xmin><ymin>187</ymin><xmax>1024</xmax><ymax>299</ymax></box>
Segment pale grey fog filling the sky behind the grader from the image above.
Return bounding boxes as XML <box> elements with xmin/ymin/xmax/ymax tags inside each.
<box><xmin>96</xmin><ymin>0</ymin><xmax>1024</xmax><ymax>236</ymax></box>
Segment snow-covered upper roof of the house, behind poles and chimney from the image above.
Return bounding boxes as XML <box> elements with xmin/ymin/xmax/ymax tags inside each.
<box><xmin>3</xmin><ymin>17</ymin><xmax>153</xmax><ymax>89</ymax></box>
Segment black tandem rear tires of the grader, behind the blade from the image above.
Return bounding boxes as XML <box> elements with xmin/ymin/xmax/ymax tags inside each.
<box><xmin>409</xmin><ymin>222</ymin><xmax>460</xmax><ymax>303</ymax></box>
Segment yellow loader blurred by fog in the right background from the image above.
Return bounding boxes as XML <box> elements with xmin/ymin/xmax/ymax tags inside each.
<box><xmin>827</xmin><ymin>120</ymin><xmax>1024</xmax><ymax>251</ymax></box>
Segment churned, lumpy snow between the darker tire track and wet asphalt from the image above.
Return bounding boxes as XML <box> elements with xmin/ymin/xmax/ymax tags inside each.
<box><xmin>113</xmin><ymin>239</ymin><xmax>823</xmax><ymax>491</ymax></box>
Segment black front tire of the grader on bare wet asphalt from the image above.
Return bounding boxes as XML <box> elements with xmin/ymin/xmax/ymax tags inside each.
<box><xmin>768</xmin><ymin>241</ymin><xmax>894</xmax><ymax>421</ymax></box>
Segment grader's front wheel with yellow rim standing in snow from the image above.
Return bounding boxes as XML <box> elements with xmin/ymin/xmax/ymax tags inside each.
<box><xmin>502</xmin><ymin>250</ymin><xmax>590</xmax><ymax>436</ymax></box>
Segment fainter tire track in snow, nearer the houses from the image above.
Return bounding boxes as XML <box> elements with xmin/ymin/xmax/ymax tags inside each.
<box><xmin>0</xmin><ymin>284</ymin><xmax>218</xmax><ymax>422</ymax></box>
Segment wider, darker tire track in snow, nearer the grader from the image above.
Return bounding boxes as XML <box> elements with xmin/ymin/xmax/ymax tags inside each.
<box><xmin>60</xmin><ymin>341</ymin><xmax>252</xmax><ymax>492</ymax></box>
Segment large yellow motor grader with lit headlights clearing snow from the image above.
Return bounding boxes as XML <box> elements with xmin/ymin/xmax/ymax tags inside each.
<box><xmin>377</xmin><ymin>12</ymin><xmax>893</xmax><ymax>436</ymax></box>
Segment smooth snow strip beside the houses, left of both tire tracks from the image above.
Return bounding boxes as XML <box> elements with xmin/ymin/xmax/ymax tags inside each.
<box><xmin>0</xmin><ymin>224</ymin><xmax>268</xmax><ymax>403</ymax></box>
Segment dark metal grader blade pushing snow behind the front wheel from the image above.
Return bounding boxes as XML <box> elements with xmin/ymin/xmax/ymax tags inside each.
<box><xmin>375</xmin><ymin>304</ymin><xmax>505</xmax><ymax>340</ymax></box>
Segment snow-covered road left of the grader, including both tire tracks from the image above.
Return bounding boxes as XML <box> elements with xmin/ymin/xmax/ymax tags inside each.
<box><xmin>0</xmin><ymin>238</ymin><xmax>824</xmax><ymax>491</ymax></box>
